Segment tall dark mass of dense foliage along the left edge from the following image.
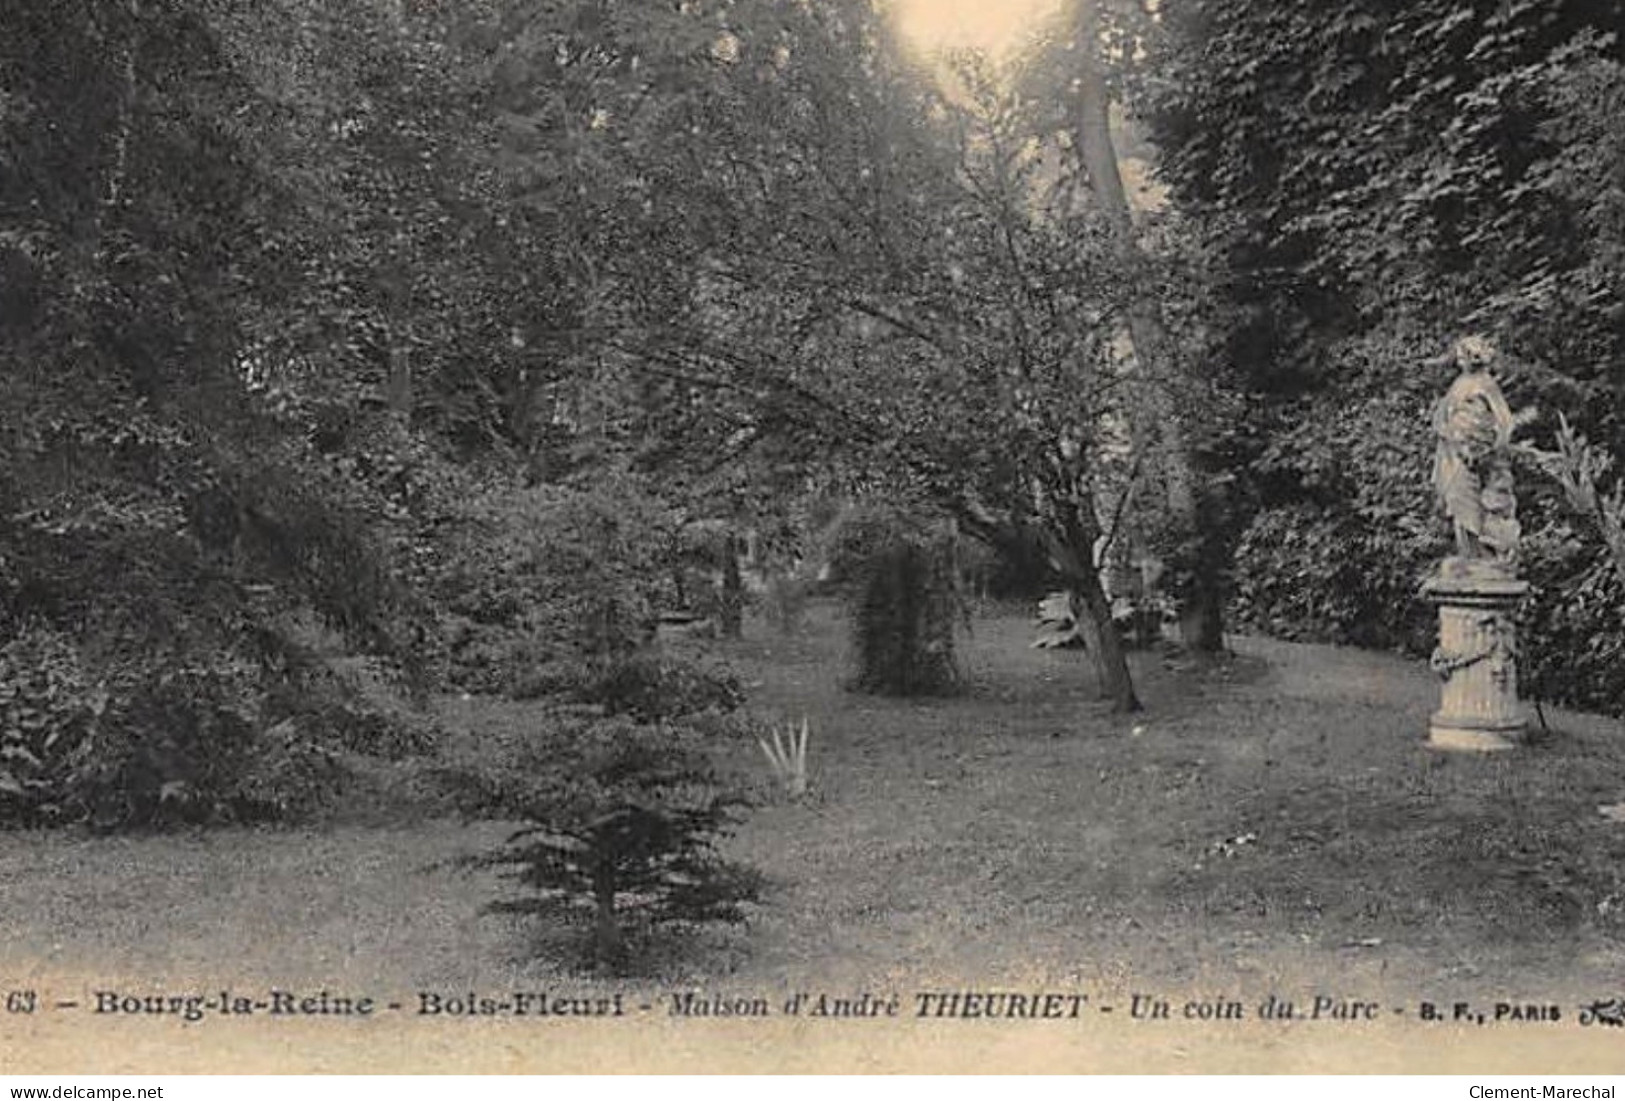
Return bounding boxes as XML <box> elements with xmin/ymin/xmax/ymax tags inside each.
<box><xmin>0</xmin><ymin>0</ymin><xmax>445</xmax><ymax>825</ymax></box>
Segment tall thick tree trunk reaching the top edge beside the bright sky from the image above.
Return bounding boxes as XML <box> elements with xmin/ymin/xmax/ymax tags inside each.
<box><xmin>1076</xmin><ymin>0</ymin><xmax>1224</xmax><ymax>654</ymax></box>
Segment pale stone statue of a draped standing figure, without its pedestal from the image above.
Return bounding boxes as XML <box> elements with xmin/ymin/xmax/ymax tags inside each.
<box><xmin>1433</xmin><ymin>336</ymin><xmax>1519</xmax><ymax>578</ymax></box>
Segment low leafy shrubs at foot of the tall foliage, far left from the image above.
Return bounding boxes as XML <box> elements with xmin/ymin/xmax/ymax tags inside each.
<box><xmin>0</xmin><ymin>613</ymin><xmax>434</xmax><ymax>830</ymax></box>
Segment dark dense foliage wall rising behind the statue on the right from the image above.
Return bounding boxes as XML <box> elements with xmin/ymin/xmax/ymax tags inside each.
<box><xmin>1141</xmin><ymin>0</ymin><xmax>1625</xmax><ymax>711</ymax></box>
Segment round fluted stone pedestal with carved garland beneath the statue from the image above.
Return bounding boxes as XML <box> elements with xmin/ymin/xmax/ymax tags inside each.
<box><xmin>1422</xmin><ymin>573</ymin><xmax>1529</xmax><ymax>752</ymax></box>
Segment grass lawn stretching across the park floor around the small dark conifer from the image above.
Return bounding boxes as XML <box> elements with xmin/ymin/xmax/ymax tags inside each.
<box><xmin>0</xmin><ymin>607</ymin><xmax>1625</xmax><ymax>1071</ymax></box>
